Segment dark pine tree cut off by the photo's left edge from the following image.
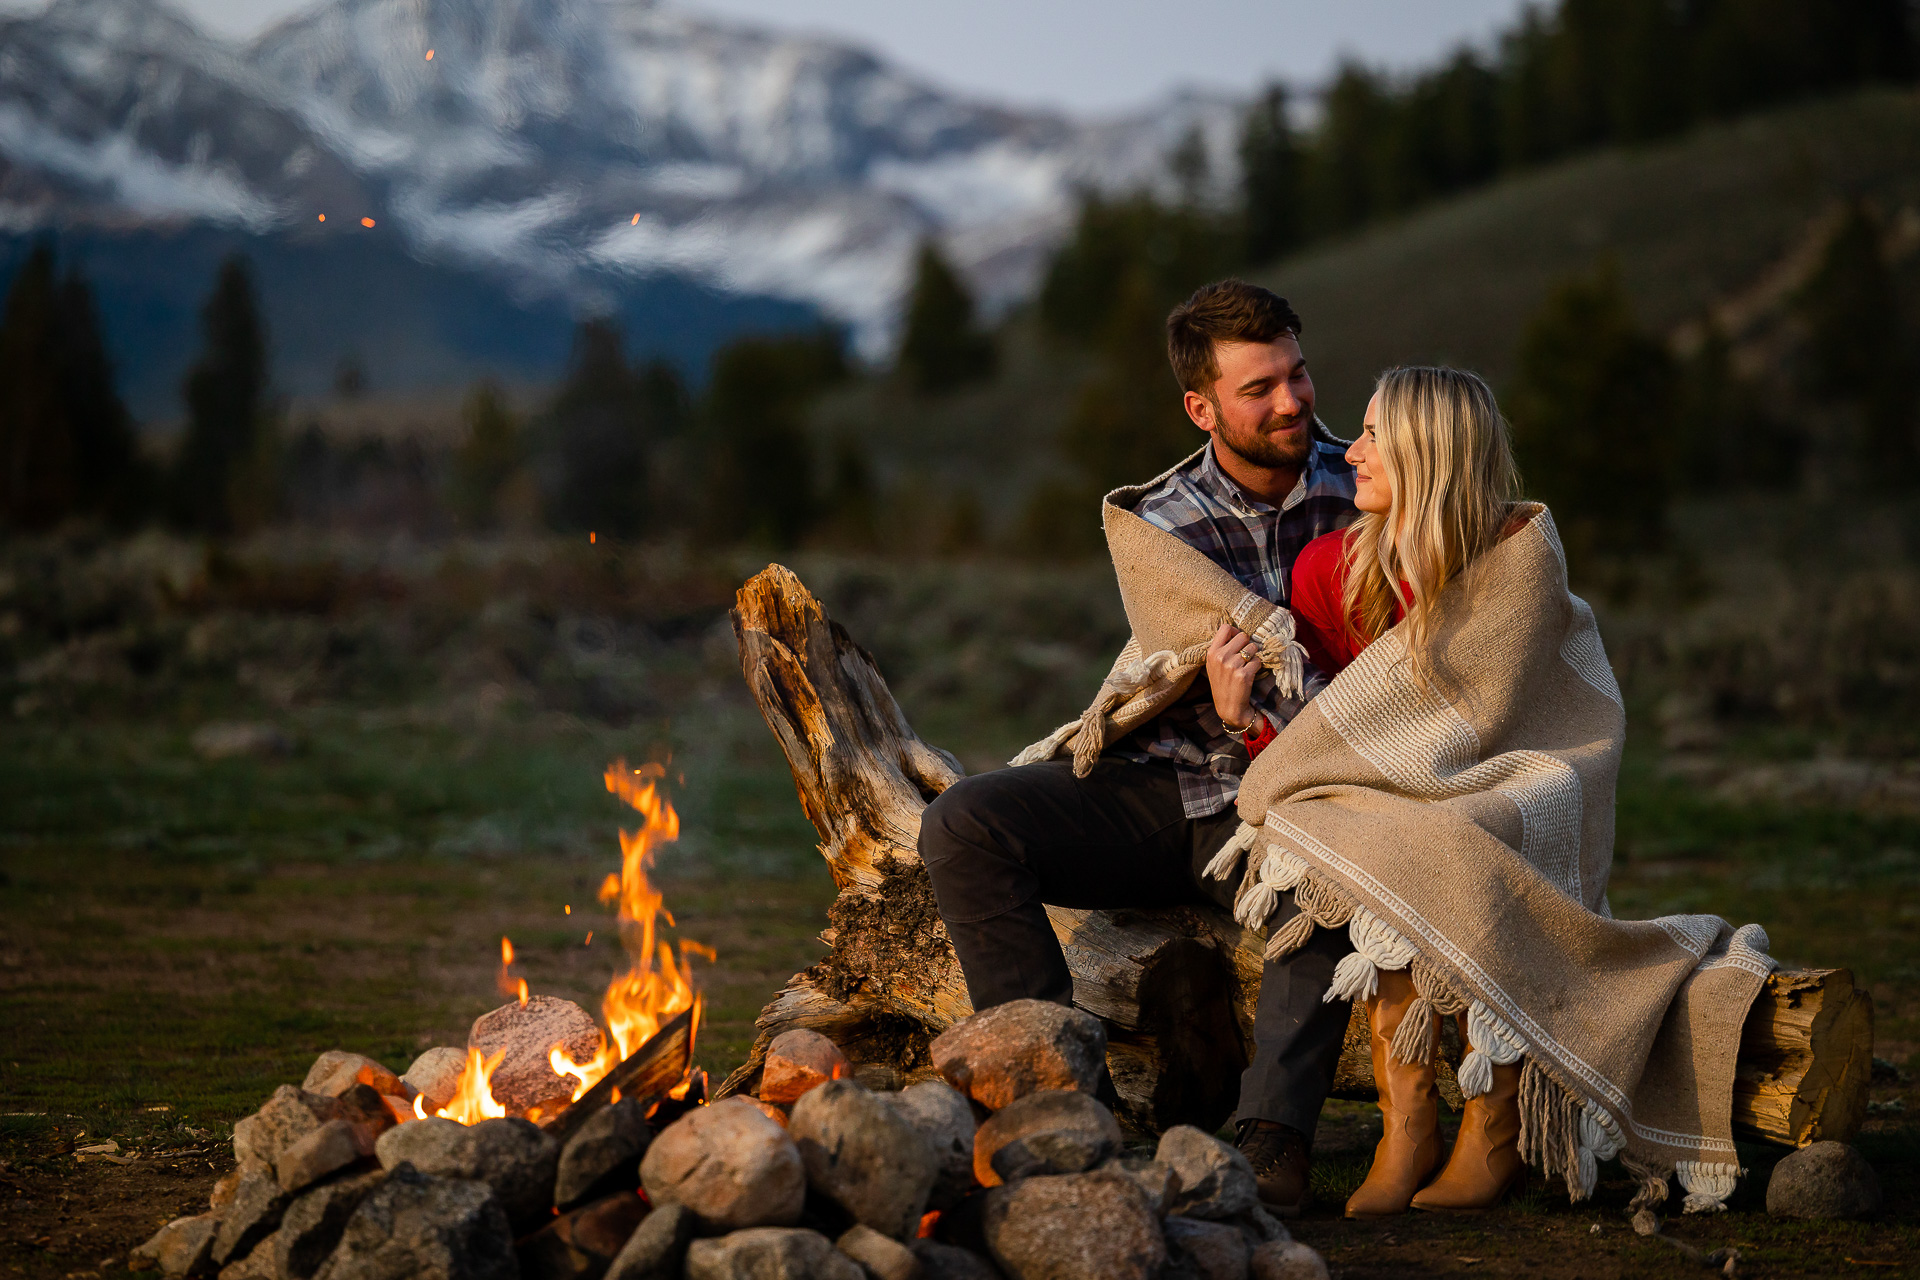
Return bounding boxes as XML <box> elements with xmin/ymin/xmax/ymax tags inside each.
<box><xmin>0</xmin><ymin>242</ymin><xmax>79</xmax><ymax>530</ymax></box>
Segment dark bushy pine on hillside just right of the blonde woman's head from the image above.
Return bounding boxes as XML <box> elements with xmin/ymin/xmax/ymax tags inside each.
<box><xmin>1507</xmin><ymin>267</ymin><xmax>1678</xmax><ymax>566</ymax></box>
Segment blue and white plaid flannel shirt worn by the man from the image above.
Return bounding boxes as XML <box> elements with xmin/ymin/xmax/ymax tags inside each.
<box><xmin>1114</xmin><ymin>418</ymin><xmax>1359</xmax><ymax>818</ymax></box>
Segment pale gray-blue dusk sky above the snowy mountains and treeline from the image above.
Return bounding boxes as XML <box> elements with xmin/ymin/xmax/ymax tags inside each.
<box><xmin>0</xmin><ymin>0</ymin><xmax>1523</xmax><ymax>111</ymax></box>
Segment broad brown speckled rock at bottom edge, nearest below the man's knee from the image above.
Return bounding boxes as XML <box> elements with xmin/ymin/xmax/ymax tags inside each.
<box><xmin>981</xmin><ymin>1171</ymin><xmax>1167</xmax><ymax>1280</ymax></box>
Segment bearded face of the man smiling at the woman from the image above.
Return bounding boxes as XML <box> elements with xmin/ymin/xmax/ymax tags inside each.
<box><xmin>1187</xmin><ymin>334</ymin><xmax>1313</xmax><ymax>470</ymax></box>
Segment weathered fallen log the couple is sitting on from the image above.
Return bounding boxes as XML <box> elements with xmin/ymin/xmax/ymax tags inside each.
<box><xmin>718</xmin><ymin>564</ymin><xmax>1872</xmax><ymax>1146</ymax></box>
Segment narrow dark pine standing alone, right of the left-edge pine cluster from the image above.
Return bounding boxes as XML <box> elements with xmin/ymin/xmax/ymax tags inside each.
<box><xmin>171</xmin><ymin>253</ymin><xmax>275</xmax><ymax>533</ymax></box>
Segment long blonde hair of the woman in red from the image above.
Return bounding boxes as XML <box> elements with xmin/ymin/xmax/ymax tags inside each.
<box><xmin>1344</xmin><ymin>367</ymin><xmax>1519</xmax><ymax>660</ymax></box>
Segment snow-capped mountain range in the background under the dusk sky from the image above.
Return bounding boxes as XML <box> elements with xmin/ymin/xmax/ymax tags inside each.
<box><xmin>0</xmin><ymin>0</ymin><xmax>1238</xmax><ymax>353</ymax></box>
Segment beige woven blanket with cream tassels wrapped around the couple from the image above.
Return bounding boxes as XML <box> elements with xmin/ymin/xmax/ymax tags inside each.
<box><xmin>1016</xmin><ymin>479</ymin><xmax>1774</xmax><ymax>1213</ymax></box>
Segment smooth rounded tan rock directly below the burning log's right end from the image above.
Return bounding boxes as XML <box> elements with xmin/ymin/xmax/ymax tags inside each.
<box><xmin>639</xmin><ymin>1098</ymin><xmax>806</xmax><ymax>1232</ymax></box>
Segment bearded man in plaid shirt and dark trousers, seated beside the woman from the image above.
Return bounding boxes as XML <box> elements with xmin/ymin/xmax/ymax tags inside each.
<box><xmin>920</xmin><ymin>280</ymin><xmax>1357</xmax><ymax>1213</ymax></box>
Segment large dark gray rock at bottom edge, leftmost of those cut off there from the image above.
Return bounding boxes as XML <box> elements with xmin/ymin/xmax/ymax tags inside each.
<box><xmin>315</xmin><ymin>1159</ymin><xmax>518</xmax><ymax>1280</ymax></box>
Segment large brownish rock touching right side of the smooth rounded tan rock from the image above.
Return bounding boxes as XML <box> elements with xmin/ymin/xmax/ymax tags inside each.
<box><xmin>787</xmin><ymin>1080</ymin><xmax>939</xmax><ymax>1240</ymax></box>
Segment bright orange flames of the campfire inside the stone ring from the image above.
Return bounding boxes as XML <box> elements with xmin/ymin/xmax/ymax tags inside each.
<box><xmin>432</xmin><ymin>760</ymin><xmax>714</xmax><ymax>1125</ymax></box>
